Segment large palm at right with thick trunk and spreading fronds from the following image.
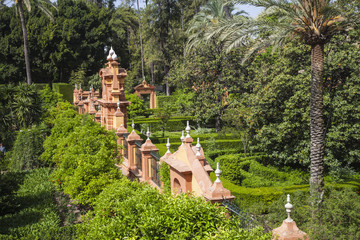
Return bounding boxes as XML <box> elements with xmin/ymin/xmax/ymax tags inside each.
<box><xmin>211</xmin><ymin>0</ymin><xmax>359</xmax><ymax>204</ymax></box>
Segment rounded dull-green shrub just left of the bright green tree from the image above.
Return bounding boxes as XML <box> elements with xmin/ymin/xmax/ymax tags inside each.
<box><xmin>7</xmin><ymin>124</ymin><xmax>49</xmax><ymax>170</ymax></box>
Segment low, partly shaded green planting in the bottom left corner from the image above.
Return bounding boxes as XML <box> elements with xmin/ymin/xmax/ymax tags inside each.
<box><xmin>0</xmin><ymin>168</ymin><xmax>74</xmax><ymax>239</ymax></box>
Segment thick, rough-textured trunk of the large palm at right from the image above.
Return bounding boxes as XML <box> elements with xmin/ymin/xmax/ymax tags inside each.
<box><xmin>310</xmin><ymin>44</ymin><xmax>324</xmax><ymax>206</ymax></box>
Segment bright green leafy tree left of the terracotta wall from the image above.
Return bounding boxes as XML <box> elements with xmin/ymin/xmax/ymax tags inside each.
<box><xmin>41</xmin><ymin>104</ymin><xmax>120</xmax><ymax>204</ymax></box>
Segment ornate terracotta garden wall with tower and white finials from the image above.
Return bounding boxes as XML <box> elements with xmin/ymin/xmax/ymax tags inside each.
<box><xmin>73</xmin><ymin>48</ymin><xmax>309</xmax><ymax>240</ymax></box>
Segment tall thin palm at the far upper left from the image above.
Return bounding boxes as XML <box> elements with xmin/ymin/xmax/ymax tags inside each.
<box><xmin>15</xmin><ymin>0</ymin><xmax>55</xmax><ymax>84</ymax></box>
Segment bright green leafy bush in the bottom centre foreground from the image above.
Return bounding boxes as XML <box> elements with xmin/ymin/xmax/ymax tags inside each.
<box><xmin>78</xmin><ymin>179</ymin><xmax>270</xmax><ymax>239</ymax></box>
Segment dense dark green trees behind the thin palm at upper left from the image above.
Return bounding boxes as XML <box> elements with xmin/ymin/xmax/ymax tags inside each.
<box><xmin>0</xmin><ymin>0</ymin><xmax>111</xmax><ymax>83</ymax></box>
